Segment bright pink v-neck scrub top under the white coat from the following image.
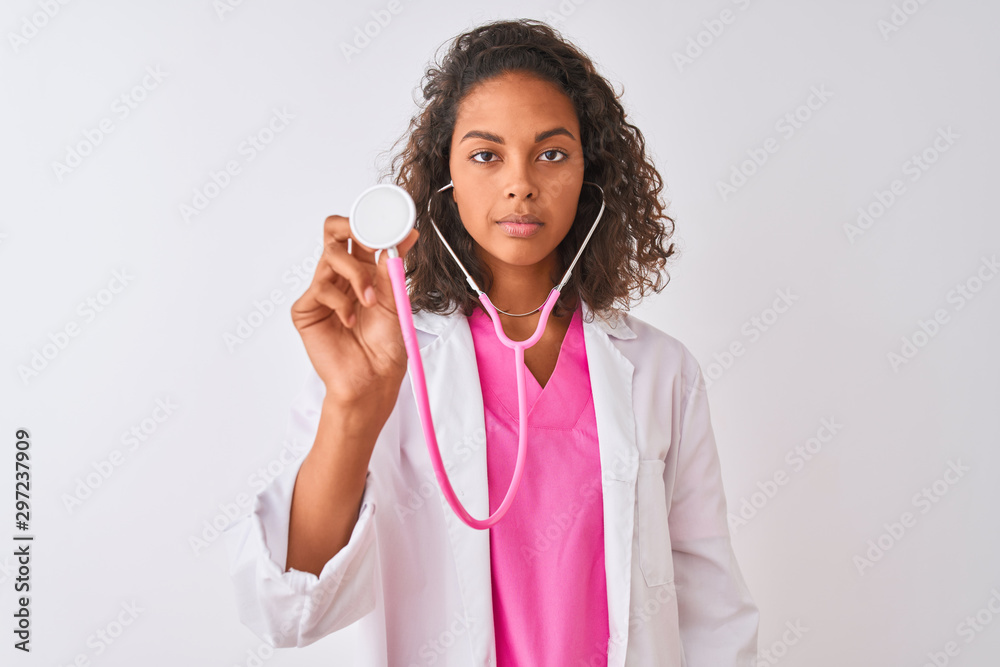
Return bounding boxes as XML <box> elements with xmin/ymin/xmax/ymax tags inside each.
<box><xmin>469</xmin><ymin>306</ymin><xmax>609</xmax><ymax>667</ymax></box>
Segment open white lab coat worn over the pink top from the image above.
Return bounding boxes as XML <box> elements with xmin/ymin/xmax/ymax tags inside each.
<box><xmin>226</xmin><ymin>303</ymin><xmax>759</xmax><ymax>667</ymax></box>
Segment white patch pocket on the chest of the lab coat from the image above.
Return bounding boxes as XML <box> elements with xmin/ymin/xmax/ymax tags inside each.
<box><xmin>636</xmin><ymin>459</ymin><xmax>674</xmax><ymax>586</ymax></box>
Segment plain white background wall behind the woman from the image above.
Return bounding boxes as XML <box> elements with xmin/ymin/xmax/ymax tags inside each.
<box><xmin>0</xmin><ymin>0</ymin><xmax>1000</xmax><ymax>667</ymax></box>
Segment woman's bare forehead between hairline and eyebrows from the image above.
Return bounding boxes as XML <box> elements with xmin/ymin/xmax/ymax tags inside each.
<box><xmin>453</xmin><ymin>72</ymin><xmax>580</xmax><ymax>137</ymax></box>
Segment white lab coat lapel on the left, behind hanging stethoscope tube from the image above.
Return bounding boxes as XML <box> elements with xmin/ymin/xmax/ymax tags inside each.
<box><xmin>410</xmin><ymin>312</ymin><xmax>496</xmax><ymax>665</ymax></box>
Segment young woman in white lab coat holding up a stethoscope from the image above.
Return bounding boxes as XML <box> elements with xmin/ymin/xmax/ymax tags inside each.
<box><xmin>227</xmin><ymin>20</ymin><xmax>758</xmax><ymax>667</ymax></box>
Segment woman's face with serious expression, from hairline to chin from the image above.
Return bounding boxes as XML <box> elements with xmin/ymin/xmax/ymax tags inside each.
<box><xmin>449</xmin><ymin>72</ymin><xmax>584</xmax><ymax>274</ymax></box>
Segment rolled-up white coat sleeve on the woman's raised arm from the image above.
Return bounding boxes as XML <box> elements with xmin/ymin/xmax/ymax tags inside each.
<box><xmin>224</xmin><ymin>376</ymin><xmax>384</xmax><ymax>647</ymax></box>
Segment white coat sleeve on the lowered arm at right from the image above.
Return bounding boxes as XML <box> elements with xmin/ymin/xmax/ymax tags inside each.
<box><xmin>668</xmin><ymin>357</ymin><xmax>760</xmax><ymax>667</ymax></box>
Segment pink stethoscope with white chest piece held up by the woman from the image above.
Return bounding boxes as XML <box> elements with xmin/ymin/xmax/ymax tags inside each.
<box><xmin>349</xmin><ymin>181</ymin><xmax>604</xmax><ymax>530</ymax></box>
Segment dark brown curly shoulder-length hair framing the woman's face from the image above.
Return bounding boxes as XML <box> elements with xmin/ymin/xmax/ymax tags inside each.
<box><xmin>379</xmin><ymin>19</ymin><xmax>675</xmax><ymax>321</ymax></box>
